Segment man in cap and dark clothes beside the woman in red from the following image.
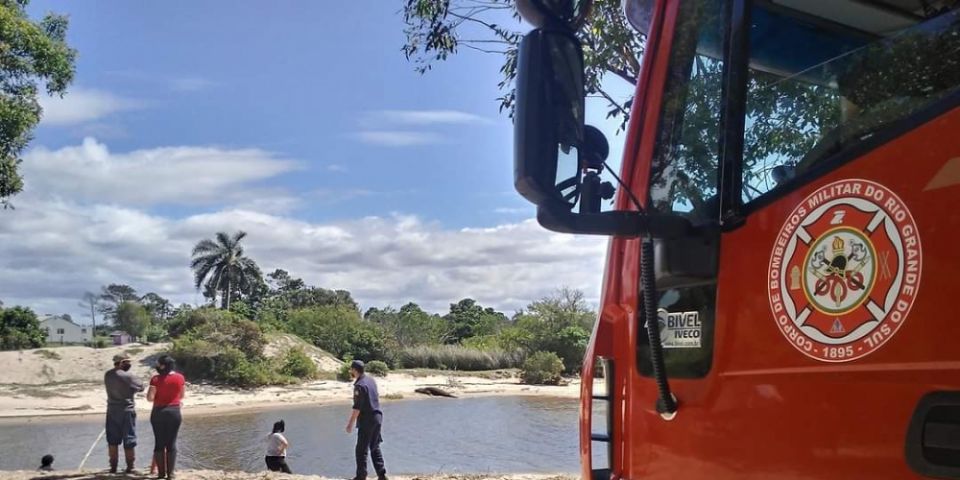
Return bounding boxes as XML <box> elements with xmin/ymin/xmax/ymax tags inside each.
<box><xmin>103</xmin><ymin>353</ymin><xmax>143</xmax><ymax>473</ymax></box>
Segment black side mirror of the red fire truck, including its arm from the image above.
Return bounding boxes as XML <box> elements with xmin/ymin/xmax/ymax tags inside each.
<box><xmin>513</xmin><ymin>28</ymin><xmax>691</xmax><ymax>238</ymax></box>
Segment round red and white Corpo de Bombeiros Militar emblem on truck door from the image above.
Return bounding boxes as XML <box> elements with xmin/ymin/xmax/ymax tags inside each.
<box><xmin>767</xmin><ymin>179</ymin><xmax>922</xmax><ymax>362</ymax></box>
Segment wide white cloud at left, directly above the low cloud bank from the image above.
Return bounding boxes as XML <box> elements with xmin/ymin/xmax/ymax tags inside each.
<box><xmin>23</xmin><ymin>138</ymin><xmax>297</xmax><ymax>207</ymax></box>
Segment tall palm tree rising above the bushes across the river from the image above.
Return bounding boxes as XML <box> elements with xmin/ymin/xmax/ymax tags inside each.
<box><xmin>190</xmin><ymin>231</ymin><xmax>262</xmax><ymax>309</ymax></box>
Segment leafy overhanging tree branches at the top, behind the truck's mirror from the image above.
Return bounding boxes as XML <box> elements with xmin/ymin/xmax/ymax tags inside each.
<box><xmin>403</xmin><ymin>0</ymin><xmax>644</xmax><ymax>128</ymax></box>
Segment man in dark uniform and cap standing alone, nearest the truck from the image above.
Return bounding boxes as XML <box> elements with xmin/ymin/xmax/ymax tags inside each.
<box><xmin>347</xmin><ymin>360</ymin><xmax>387</xmax><ymax>480</ymax></box>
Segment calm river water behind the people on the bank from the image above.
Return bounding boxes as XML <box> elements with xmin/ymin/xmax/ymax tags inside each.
<box><xmin>0</xmin><ymin>397</ymin><xmax>579</xmax><ymax>478</ymax></box>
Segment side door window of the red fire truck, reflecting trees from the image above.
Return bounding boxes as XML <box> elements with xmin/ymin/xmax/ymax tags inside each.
<box><xmin>742</xmin><ymin>2</ymin><xmax>960</xmax><ymax>203</ymax></box>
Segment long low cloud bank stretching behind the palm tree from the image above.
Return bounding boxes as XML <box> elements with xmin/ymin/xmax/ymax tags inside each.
<box><xmin>0</xmin><ymin>196</ymin><xmax>606</xmax><ymax>318</ymax></box>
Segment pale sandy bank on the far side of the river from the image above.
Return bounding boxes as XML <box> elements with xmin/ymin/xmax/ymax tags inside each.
<box><xmin>0</xmin><ymin>339</ymin><xmax>580</xmax><ymax>418</ymax></box>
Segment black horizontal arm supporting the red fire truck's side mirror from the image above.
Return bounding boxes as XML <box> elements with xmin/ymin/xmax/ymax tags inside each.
<box><xmin>537</xmin><ymin>206</ymin><xmax>694</xmax><ymax>238</ymax></box>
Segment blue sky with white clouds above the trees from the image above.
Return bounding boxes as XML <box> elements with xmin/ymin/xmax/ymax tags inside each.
<box><xmin>0</xmin><ymin>0</ymin><xmax>629</xmax><ymax>313</ymax></box>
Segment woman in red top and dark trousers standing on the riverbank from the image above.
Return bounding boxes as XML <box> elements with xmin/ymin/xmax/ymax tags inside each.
<box><xmin>147</xmin><ymin>355</ymin><xmax>185</xmax><ymax>479</ymax></box>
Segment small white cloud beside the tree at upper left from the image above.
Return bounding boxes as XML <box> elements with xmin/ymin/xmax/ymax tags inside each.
<box><xmin>39</xmin><ymin>87</ymin><xmax>144</xmax><ymax>126</ymax></box>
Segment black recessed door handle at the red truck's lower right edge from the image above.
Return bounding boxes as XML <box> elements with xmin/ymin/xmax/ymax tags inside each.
<box><xmin>905</xmin><ymin>392</ymin><xmax>960</xmax><ymax>479</ymax></box>
